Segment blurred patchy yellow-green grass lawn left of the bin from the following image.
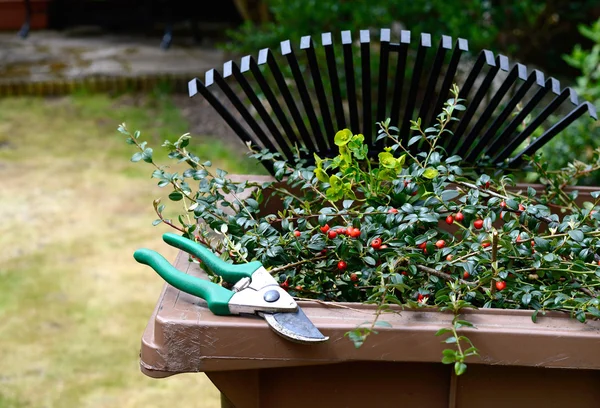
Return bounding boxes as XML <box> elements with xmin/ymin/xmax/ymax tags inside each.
<box><xmin>0</xmin><ymin>91</ymin><xmax>260</xmax><ymax>408</ymax></box>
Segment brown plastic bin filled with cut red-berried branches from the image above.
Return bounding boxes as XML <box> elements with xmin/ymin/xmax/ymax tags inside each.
<box><xmin>140</xmin><ymin>176</ymin><xmax>600</xmax><ymax>408</ymax></box>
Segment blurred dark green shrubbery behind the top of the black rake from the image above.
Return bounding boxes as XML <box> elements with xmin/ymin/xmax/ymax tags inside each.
<box><xmin>226</xmin><ymin>0</ymin><xmax>600</xmax><ymax>73</ymax></box>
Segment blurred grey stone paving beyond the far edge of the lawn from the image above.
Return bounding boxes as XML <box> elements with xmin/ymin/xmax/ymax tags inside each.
<box><xmin>0</xmin><ymin>31</ymin><xmax>226</xmax><ymax>84</ymax></box>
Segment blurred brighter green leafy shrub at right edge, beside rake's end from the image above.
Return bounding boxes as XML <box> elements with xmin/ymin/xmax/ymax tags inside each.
<box><xmin>542</xmin><ymin>20</ymin><xmax>600</xmax><ymax>185</ymax></box>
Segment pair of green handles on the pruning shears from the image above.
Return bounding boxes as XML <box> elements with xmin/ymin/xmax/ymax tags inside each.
<box><xmin>133</xmin><ymin>233</ymin><xmax>262</xmax><ymax>315</ymax></box>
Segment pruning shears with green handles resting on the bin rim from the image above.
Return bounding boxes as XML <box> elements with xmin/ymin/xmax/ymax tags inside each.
<box><xmin>133</xmin><ymin>233</ymin><xmax>328</xmax><ymax>343</ymax></box>
